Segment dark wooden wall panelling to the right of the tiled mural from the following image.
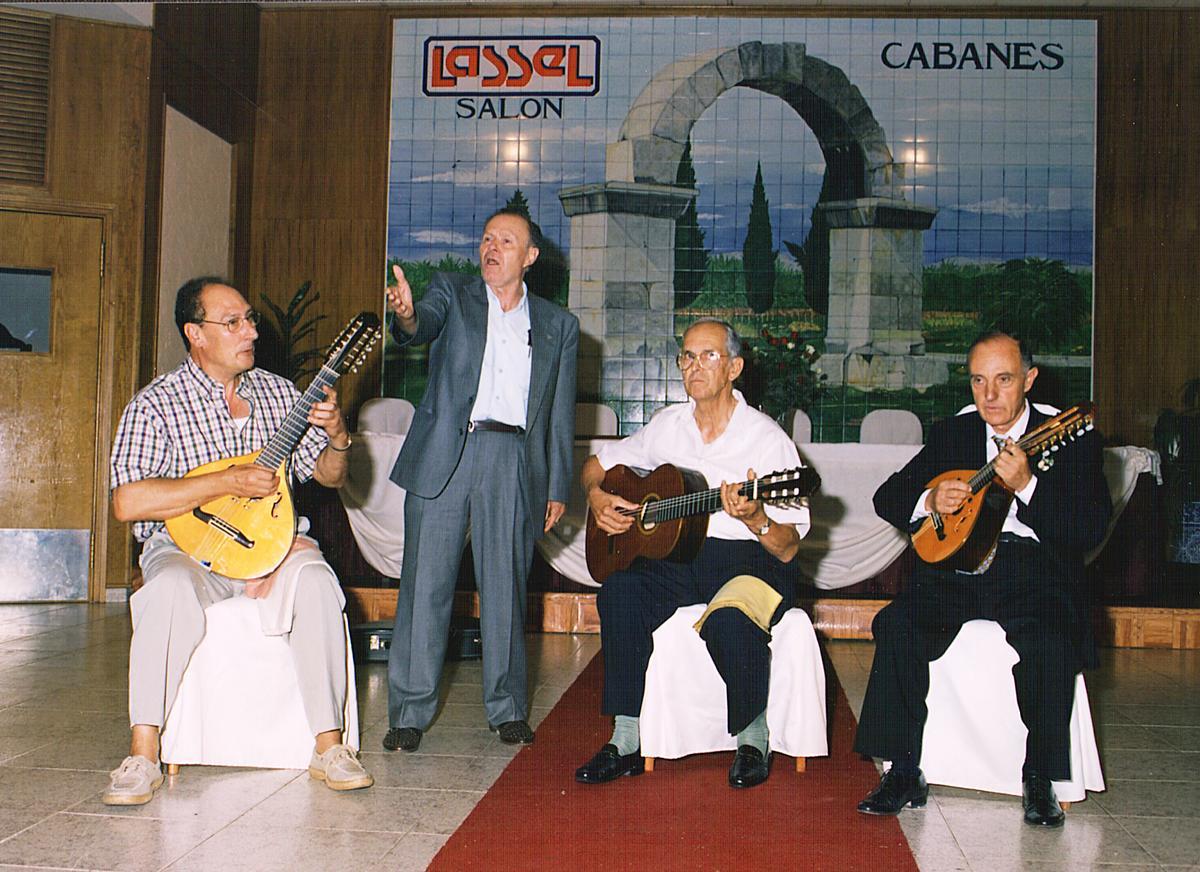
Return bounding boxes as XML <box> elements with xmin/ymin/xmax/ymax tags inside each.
<box><xmin>1093</xmin><ymin>10</ymin><xmax>1200</xmax><ymax>446</ymax></box>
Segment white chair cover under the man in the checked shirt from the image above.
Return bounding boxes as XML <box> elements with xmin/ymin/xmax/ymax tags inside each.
<box><xmin>162</xmin><ymin>596</ymin><xmax>359</xmax><ymax>769</ymax></box>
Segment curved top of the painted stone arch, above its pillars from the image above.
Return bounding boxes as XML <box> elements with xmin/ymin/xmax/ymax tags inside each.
<box><xmin>607</xmin><ymin>42</ymin><xmax>902</xmax><ymax>199</ymax></box>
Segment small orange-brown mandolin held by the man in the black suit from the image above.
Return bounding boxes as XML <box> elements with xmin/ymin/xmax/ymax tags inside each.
<box><xmin>912</xmin><ymin>403</ymin><xmax>1096</xmax><ymax>572</ymax></box>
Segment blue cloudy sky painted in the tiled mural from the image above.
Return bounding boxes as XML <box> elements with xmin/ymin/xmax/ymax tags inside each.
<box><xmin>388</xmin><ymin>18</ymin><xmax>1096</xmax><ymax>266</ymax></box>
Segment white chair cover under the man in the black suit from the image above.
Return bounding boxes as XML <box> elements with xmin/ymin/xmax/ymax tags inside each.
<box><xmin>920</xmin><ymin>620</ymin><xmax>1104</xmax><ymax>802</ymax></box>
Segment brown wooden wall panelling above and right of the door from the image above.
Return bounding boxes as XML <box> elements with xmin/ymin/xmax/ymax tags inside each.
<box><xmin>0</xmin><ymin>18</ymin><xmax>150</xmax><ymax>596</ymax></box>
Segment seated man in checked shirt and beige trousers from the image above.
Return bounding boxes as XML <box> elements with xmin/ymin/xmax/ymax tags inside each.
<box><xmin>103</xmin><ymin>277</ymin><xmax>373</xmax><ymax>805</ymax></box>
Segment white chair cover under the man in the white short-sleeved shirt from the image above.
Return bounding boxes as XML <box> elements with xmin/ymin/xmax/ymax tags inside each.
<box><xmin>640</xmin><ymin>605</ymin><xmax>829</xmax><ymax>759</ymax></box>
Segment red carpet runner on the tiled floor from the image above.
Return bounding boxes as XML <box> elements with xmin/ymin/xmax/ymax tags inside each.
<box><xmin>430</xmin><ymin>655</ymin><xmax>917</xmax><ymax>872</ymax></box>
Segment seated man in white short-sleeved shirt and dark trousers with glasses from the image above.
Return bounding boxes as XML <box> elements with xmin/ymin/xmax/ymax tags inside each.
<box><xmin>575</xmin><ymin>319</ymin><xmax>809</xmax><ymax>788</ymax></box>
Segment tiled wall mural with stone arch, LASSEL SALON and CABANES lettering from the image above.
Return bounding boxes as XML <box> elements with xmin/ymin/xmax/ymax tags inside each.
<box><xmin>384</xmin><ymin>18</ymin><xmax>1096</xmax><ymax>441</ymax></box>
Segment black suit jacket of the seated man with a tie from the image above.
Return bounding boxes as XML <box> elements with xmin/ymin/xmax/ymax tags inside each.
<box><xmin>875</xmin><ymin>408</ymin><xmax>1112</xmax><ymax>581</ymax></box>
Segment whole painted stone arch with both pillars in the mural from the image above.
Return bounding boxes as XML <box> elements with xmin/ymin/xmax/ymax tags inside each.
<box><xmin>558</xmin><ymin>42</ymin><xmax>947</xmax><ymax>433</ymax></box>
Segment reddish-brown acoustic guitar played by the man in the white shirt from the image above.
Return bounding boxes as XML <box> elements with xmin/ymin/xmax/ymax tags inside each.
<box><xmin>584</xmin><ymin>463</ymin><xmax>821</xmax><ymax>583</ymax></box>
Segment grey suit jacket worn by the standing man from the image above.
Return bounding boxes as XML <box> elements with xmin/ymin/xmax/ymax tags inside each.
<box><xmin>391</xmin><ymin>272</ymin><xmax>580</xmax><ymax>535</ymax></box>
